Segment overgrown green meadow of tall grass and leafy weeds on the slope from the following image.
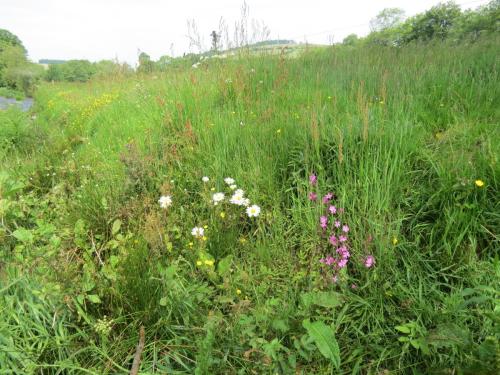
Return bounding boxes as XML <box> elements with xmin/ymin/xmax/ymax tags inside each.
<box><xmin>0</xmin><ymin>36</ymin><xmax>500</xmax><ymax>374</ymax></box>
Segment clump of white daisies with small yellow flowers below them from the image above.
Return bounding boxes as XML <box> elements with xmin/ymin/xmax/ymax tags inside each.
<box><xmin>158</xmin><ymin>176</ymin><xmax>261</xmax><ymax>273</ymax></box>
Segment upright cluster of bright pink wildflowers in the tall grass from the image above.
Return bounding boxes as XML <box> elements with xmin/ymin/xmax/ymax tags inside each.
<box><xmin>308</xmin><ymin>174</ymin><xmax>375</xmax><ymax>288</ymax></box>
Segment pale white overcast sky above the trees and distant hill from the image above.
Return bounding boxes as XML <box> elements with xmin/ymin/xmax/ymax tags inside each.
<box><xmin>0</xmin><ymin>0</ymin><xmax>488</xmax><ymax>66</ymax></box>
